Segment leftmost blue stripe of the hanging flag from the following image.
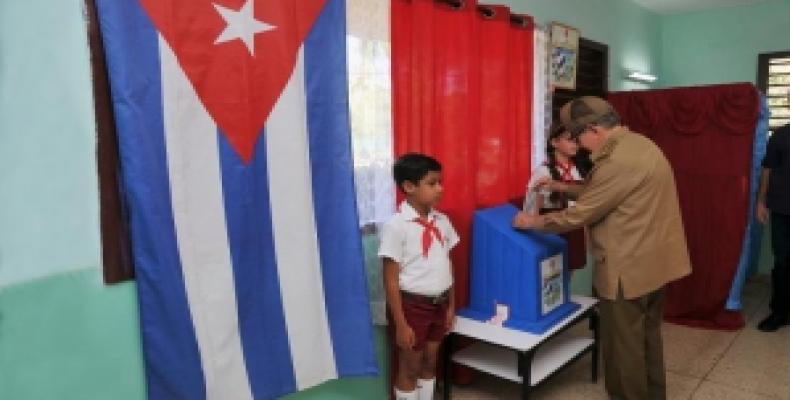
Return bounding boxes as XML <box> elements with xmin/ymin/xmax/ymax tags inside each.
<box><xmin>97</xmin><ymin>0</ymin><xmax>206</xmax><ymax>400</ymax></box>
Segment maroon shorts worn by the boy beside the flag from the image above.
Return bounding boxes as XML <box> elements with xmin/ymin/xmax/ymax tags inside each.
<box><xmin>401</xmin><ymin>294</ymin><xmax>447</xmax><ymax>350</ymax></box>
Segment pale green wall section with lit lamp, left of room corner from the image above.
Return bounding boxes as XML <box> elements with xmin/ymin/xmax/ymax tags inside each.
<box><xmin>481</xmin><ymin>0</ymin><xmax>661</xmax><ymax>90</ymax></box>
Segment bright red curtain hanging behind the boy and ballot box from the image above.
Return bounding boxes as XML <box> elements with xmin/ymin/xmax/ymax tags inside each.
<box><xmin>391</xmin><ymin>0</ymin><xmax>533</xmax><ymax>307</ymax></box>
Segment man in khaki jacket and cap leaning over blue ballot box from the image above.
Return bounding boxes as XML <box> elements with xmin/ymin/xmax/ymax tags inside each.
<box><xmin>513</xmin><ymin>97</ymin><xmax>691</xmax><ymax>400</ymax></box>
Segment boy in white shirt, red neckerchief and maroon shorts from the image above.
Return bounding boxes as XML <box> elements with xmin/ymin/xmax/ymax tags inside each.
<box><xmin>379</xmin><ymin>153</ymin><xmax>458</xmax><ymax>400</ymax></box>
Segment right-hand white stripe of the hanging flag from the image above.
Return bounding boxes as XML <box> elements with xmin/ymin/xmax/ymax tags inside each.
<box><xmin>264</xmin><ymin>47</ymin><xmax>337</xmax><ymax>390</ymax></box>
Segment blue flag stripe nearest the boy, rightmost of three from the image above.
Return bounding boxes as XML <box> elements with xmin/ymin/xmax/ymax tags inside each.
<box><xmin>304</xmin><ymin>0</ymin><xmax>378</xmax><ymax>376</ymax></box>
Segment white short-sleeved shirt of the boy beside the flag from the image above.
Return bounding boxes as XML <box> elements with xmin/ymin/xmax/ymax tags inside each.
<box><xmin>379</xmin><ymin>201</ymin><xmax>459</xmax><ymax>296</ymax></box>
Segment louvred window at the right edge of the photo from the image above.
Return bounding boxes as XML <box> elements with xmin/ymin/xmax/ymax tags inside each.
<box><xmin>757</xmin><ymin>51</ymin><xmax>790</xmax><ymax>130</ymax></box>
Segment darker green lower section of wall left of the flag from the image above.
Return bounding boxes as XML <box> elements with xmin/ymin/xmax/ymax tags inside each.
<box><xmin>0</xmin><ymin>268</ymin><xmax>145</xmax><ymax>400</ymax></box>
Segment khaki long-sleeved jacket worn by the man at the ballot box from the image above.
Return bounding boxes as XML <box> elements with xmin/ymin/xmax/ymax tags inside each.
<box><xmin>543</xmin><ymin>127</ymin><xmax>691</xmax><ymax>300</ymax></box>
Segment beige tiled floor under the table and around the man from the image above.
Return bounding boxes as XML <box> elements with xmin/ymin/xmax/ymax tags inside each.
<box><xmin>448</xmin><ymin>276</ymin><xmax>790</xmax><ymax>400</ymax></box>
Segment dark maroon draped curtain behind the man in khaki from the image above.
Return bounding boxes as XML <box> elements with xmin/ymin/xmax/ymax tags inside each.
<box><xmin>609</xmin><ymin>84</ymin><xmax>760</xmax><ymax>330</ymax></box>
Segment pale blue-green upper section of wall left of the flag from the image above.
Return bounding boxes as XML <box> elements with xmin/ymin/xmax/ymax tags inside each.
<box><xmin>0</xmin><ymin>0</ymin><xmax>100</xmax><ymax>287</ymax></box>
